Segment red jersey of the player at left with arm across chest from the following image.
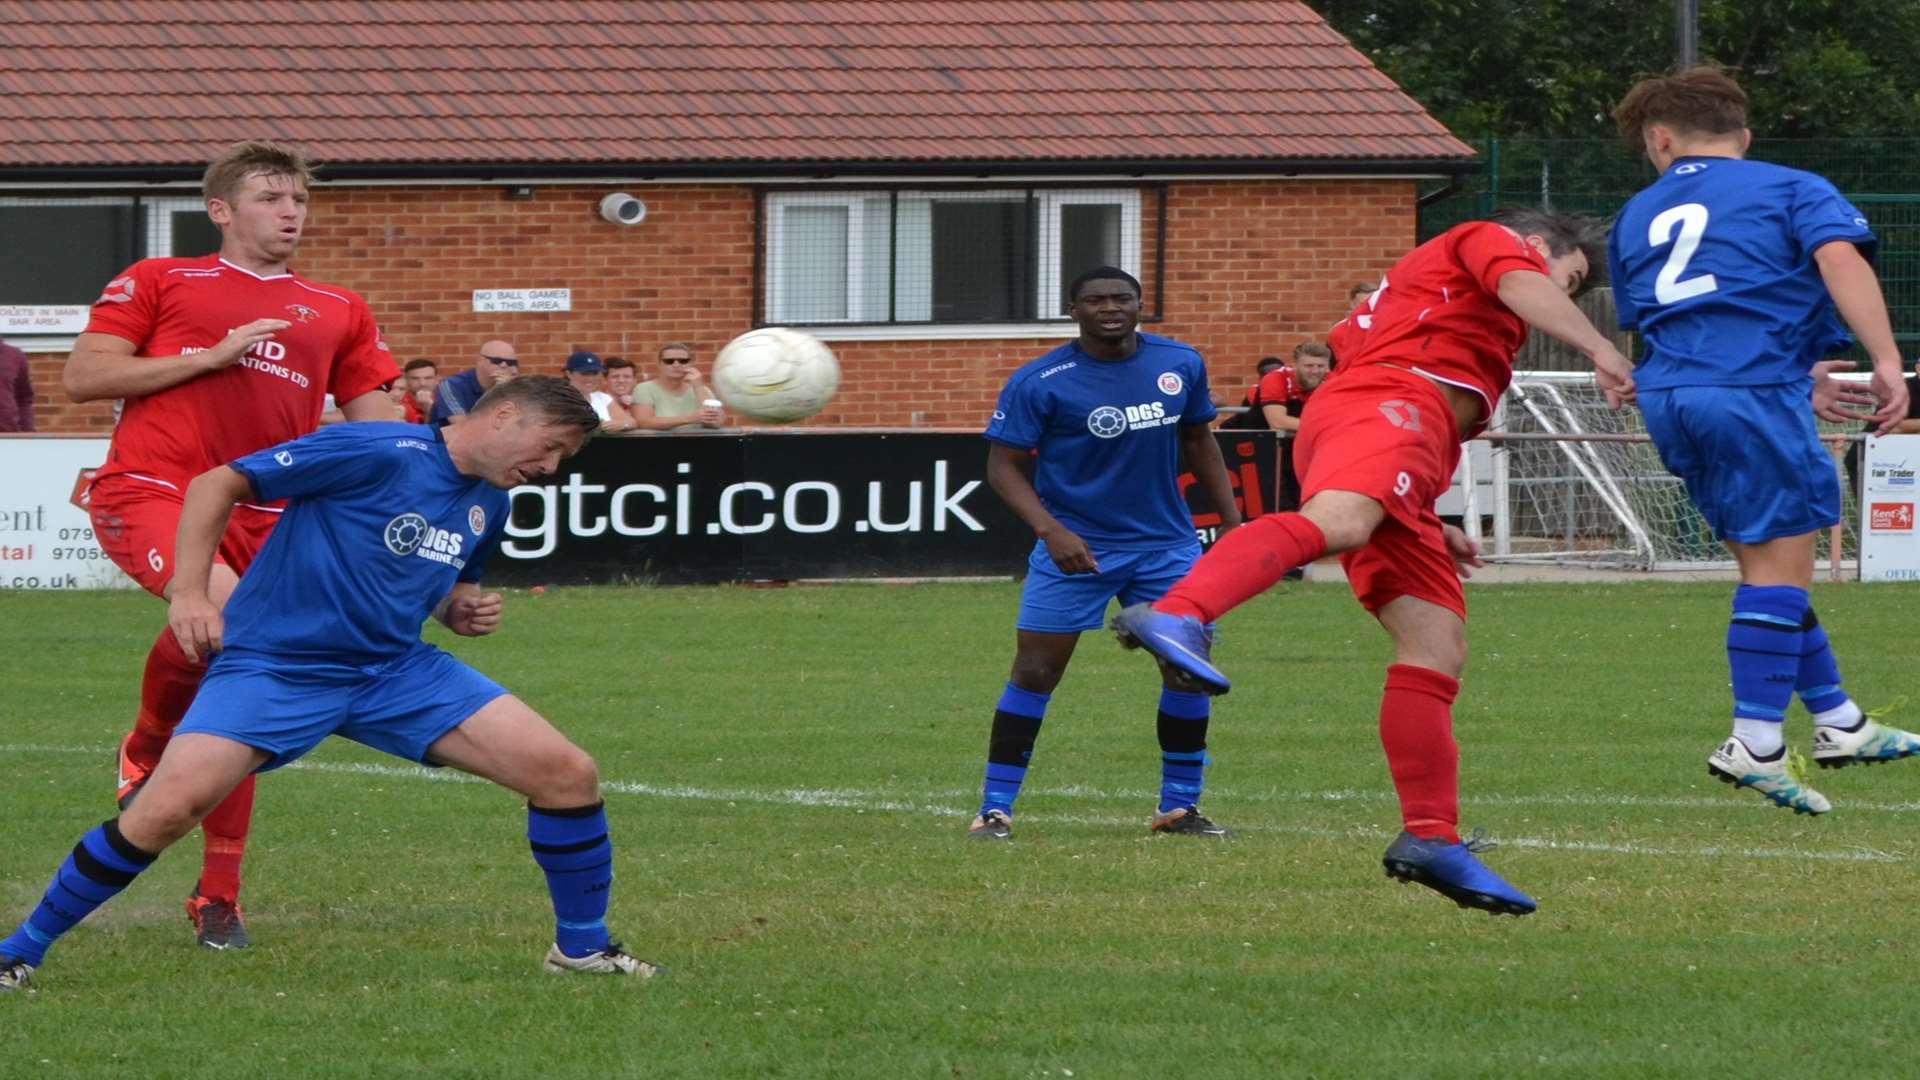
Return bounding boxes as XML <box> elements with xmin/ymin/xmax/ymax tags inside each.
<box><xmin>86</xmin><ymin>256</ymin><xmax>399</xmax><ymax>490</ymax></box>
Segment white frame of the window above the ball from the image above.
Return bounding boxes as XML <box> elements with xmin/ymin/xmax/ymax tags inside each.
<box><xmin>760</xmin><ymin>186</ymin><xmax>1142</xmax><ymax>332</ymax></box>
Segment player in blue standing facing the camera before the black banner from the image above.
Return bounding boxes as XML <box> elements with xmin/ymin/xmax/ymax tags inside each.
<box><xmin>968</xmin><ymin>267</ymin><xmax>1240</xmax><ymax>840</ymax></box>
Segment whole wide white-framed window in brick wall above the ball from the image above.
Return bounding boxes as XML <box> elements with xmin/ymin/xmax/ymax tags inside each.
<box><xmin>762</xmin><ymin>188</ymin><xmax>1140</xmax><ymax>325</ymax></box>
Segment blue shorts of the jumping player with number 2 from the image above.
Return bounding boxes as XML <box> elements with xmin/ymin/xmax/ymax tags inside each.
<box><xmin>1640</xmin><ymin>382</ymin><xmax>1839</xmax><ymax>544</ymax></box>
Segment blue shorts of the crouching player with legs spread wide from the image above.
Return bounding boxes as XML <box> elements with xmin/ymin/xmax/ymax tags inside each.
<box><xmin>175</xmin><ymin>642</ymin><xmax>507</xmax><ymax>773</ymax></box>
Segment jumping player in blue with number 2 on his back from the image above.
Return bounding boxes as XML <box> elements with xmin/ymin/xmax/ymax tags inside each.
<box><xmin>1607</xmin><ymin>65</ymin><xmax>1920</xmax><ymax>813</ymax></box>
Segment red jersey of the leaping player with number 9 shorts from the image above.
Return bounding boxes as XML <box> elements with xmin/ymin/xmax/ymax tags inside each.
<box><xmin>1327</xmin><ymin>221</ymin><xmax>1548</xmax><ymax>426</ymax></box>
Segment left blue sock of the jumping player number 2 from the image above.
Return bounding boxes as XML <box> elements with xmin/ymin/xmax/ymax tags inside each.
<box><xmin>1726</xmin><ymin>584</ymin><xmax>1807</xmax><ymax>757</ymax></box>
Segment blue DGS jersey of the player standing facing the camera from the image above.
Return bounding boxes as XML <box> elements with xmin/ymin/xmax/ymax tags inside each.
<box><xmin>987</xmin><ymin>334</ymin><xmax>1217</xmax><ymax>550</ymax></box>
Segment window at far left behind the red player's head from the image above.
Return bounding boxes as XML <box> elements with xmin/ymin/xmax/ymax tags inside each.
<box><xmin>0</xmin><ymin>196</ymin><xmax>221</xmax><ymax>338</ymax></box>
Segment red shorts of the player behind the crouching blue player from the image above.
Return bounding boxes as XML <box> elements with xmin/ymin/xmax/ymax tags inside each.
<box><xmin>86</xmin><ymin>475</ymin><xmax>280</xmax><ymax>598</ymax></box>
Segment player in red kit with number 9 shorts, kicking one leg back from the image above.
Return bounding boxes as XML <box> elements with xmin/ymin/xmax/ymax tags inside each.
<box><xmin>1114</xmin><ymin>209</ymin><xmax>1634</xmax><ymax>915</ymax></box>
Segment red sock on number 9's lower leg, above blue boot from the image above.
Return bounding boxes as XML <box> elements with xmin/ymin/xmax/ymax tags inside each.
<box><xmin>1380</xmin><ymin>663</ymin><xmax>1459</xmax><ymax>844</ymax></box>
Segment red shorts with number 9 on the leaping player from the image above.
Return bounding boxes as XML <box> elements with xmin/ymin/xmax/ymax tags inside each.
<box><xmin>1294</xmin><ymin>365</ymin><xmax>1467</xmax><ymax>619</ymax></box>
